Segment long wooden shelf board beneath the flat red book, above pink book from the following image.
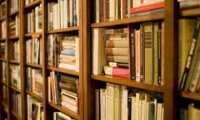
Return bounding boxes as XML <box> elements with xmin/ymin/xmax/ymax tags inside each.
<box><xmin>91</xmin><ymin>13</ymin><xmax>164</xmax><ymax>28</ymax></box>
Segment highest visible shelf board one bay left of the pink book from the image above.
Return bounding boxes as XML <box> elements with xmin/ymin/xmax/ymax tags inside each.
<box><xmin>48</xmin><ymin>27</ymin><xmax>79</xmax><ymax>34</ymax></box>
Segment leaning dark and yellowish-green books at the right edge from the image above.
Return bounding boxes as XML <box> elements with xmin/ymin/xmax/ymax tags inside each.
<box><xmin>179</xmin><ymin>19</ymin><xmax>200</xmax><ymax>92</ymax></box>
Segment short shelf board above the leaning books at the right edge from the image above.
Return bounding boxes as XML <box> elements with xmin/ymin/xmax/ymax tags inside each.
<box><xmin>179</xmin><ymin>7</ymin><xmax>200</xmax><ymax>17</ymax></box>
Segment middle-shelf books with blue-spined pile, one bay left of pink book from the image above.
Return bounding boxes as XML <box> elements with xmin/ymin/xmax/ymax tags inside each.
<box><xmin>47</xmin><ymin>34</ymin><xmax>79</xmax><ymax>72</ymax></box>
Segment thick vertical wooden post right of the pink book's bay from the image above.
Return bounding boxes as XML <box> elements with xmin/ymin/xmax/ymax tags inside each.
<box><xmin>162</xmin><ymin>0</ymin><xmax>178</xmax><ymax>120</ymax></box>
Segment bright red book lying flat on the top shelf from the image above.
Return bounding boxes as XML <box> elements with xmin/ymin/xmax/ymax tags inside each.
<box><xmin>130</xmin><ymin>2</ymin><xmax>165</xmax><ymax>13</ymax></box>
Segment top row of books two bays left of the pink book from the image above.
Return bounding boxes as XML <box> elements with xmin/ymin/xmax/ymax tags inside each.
<box><xmin>26</xmin><ymin>4</ymin><xmax>42</xmax><ymax>33</ymax></box>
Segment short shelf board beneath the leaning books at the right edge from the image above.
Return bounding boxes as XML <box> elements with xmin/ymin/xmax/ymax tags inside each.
<box><xmin>180</xmin><ymin>92</ymin><xmax>200</xmax><ymax>101</ymax></box>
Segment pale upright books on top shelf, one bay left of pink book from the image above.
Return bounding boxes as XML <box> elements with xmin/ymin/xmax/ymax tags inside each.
<box><xmin>48</xmin><ymin>0</ymin><xmax>79</xmax><ymax>30</ymax></box>
